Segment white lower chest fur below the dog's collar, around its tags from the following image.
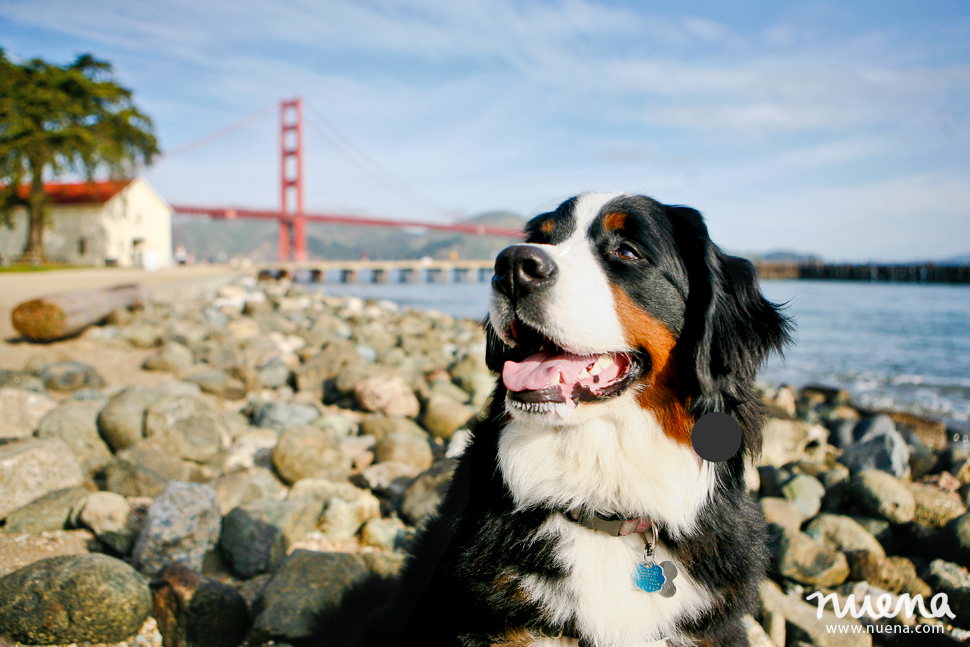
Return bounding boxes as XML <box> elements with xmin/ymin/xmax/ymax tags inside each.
<box><xmin>521</xmin><ymin>515</ymin><xmax>711</xmax><ymax>647</ymax></box>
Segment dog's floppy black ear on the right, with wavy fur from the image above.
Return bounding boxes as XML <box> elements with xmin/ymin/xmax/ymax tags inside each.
<box><xmin>669</xmin><ymin>207</ymin><xmax>792</xmax><ymax>411</ymax></box>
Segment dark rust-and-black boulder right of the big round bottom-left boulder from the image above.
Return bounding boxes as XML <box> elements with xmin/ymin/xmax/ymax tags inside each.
<box><xmin>152</xmin><ymin>563</ymin><xmax>249</xmax><ymax>647</ymax></box>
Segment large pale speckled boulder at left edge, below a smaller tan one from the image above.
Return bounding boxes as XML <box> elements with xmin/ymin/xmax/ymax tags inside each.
<box><xmin>0</xmin><ymin>438</ymin><xmax>84</xmax><ymax>518</ymax></box>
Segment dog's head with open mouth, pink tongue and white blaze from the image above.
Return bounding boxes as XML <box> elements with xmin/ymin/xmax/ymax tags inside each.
<box><xmin>486</xmin><ymin>194</ymin><xmax>789</xmax><ymax>442</ymax></box>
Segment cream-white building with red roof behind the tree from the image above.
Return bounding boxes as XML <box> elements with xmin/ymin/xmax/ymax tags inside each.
<box><xmin>0</xmin><ymin>178</ymin><xmax>172</xmax><ymax>269</ymax></box>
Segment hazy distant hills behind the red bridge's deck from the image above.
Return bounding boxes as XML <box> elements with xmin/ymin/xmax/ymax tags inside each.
<box><xmin>172</xmin><ymin>211</ymin><xmax>525</xmax><ymax>261</ymax></box>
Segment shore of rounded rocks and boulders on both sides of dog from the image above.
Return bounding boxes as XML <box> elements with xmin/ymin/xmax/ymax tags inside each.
<box><xmin>0</xmin><ymin>278</ymin><xmax>970</xmax><ymax>647</ymax></box>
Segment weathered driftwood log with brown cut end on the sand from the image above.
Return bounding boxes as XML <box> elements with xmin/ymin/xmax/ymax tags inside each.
<box><xmin>10</xmin><ymin>284</ymin><xmax>149</xmax><ymax>342</ymax></box>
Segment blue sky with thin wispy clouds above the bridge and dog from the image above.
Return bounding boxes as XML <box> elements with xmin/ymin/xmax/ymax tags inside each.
<box><xmin>0</xmin><ymin>0</ymin><xmax>970</xmax><ymax>260</ymax></box>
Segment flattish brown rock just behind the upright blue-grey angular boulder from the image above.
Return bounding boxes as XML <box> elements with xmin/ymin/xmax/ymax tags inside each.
<box><xmin>104</xmin><ymin>439</ymin><xmax>196</xmax><ymax>498</ymax></box>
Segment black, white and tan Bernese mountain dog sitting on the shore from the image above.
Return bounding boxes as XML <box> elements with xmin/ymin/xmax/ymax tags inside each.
<box><xmin>370</xmin><ymin>193</ymin><xmax>790</xmax><ymax>647</ymax></box>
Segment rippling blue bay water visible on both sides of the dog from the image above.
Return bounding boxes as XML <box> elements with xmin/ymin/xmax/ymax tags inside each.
<box><xmin>323</xmin><ymin>281</ymin><xmax>970</xmax><ymax>430</ymax></box>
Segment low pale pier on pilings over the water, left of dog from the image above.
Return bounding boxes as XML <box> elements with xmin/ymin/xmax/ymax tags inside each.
<box><xmin>258</xmin><ymin>258</ymin><xmax>495</xmax><ymax>283</ymax></box>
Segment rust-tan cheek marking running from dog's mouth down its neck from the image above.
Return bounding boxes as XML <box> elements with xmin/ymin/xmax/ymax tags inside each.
<box><xmin>610</xmin><ymin>285</ymin><xmax>694</xmax><ymax>447</ymax></box>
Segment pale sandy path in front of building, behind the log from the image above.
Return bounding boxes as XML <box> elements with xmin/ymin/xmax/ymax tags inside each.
<box><xmin>0</xmin><ymin>265</ymin><xmax>244</xmax><ymax>340</ymax></box>
